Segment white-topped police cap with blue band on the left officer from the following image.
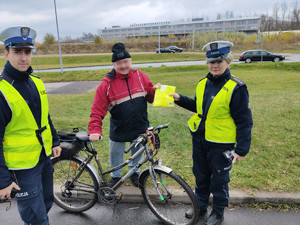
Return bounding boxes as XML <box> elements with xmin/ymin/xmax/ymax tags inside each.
<box><xmin>0</xmin><ymin>26</ymin><xmax>36</xmax><ymax>48</ymax></box>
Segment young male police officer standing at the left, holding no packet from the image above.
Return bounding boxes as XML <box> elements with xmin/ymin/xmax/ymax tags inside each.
<box><xmin>0</xmin><ymin>26</ymin><xmax>61</xmax><ymax>225</ymax></box>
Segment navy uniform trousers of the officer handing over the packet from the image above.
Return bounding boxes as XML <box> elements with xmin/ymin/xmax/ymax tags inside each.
<box><xmin>193</xmin><ymin>135</ymin><xmax>232</xmax><ymax>215</ymax></box>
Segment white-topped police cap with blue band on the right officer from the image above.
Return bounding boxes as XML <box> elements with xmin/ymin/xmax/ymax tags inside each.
<box><xmin>202</xmin><ymin>41</ymin><xmax>233</xmax><ymax>63</ymax></box>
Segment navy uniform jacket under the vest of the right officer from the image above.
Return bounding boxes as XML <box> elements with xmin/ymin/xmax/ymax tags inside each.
<box><xmin>175</xmin><ymin>69</ymin><xmax>253</xmax><ymax>156</ymax></box>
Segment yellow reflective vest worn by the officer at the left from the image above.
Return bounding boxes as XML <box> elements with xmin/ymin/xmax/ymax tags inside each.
<box><xmin>0</xmin><ymin>76</ymin><xmax>52</xmax><ymax>170</ymax></box>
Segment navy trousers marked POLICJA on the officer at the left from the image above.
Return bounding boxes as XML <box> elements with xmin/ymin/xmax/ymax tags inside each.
<box><xmin>12</xmin><ymin>151</ymin><xmax>53</xmax><ymax>225</ymax></box>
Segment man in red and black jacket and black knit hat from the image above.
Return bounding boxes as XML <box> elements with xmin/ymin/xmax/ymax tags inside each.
<box><xmin>89</xmin><ymin>43</ymin><xmax>160</xmax><ymax>187</ymax></box>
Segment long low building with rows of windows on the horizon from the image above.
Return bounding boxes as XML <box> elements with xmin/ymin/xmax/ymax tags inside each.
<box><xmin>98</xmin><ymin>17</ymin><xmax>261</xmax><ymax>41</ymax></box>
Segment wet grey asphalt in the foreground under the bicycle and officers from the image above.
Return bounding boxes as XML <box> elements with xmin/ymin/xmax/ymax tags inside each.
<box><xmin>0</xmin><ymin>201</ymin><xmax>300</xmax><ymax>225</ymax></box>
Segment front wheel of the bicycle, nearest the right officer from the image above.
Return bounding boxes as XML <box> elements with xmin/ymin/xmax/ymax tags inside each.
<box><xmin>140</xmin><ymin>169</ymin><xmax>199</xmax><ymax>225</ymax></box>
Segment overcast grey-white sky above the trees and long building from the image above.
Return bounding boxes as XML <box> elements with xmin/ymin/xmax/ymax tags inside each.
<box><xmin>0</xmin><ymin>0</ymin><xmax>300</xmax><ymax>42</ymax></box>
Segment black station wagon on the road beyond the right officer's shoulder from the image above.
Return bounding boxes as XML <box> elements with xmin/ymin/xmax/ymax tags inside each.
<box><xmin>239</xmin><ymin>50</ymin><xmax>285</xmax><ymax>63</ymax></box>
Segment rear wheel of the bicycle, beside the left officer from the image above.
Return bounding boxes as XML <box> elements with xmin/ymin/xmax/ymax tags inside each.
<box><xmin>51</xmin><ymin>157</ymin><xmax>99</xmax><ymax>213</ymax></box>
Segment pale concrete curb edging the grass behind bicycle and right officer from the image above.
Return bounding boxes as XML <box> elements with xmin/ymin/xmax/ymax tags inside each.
<box><xmin>116</xmin><ymin>186</ymin><xmax>300</xmax><ymax>205</ymax></box>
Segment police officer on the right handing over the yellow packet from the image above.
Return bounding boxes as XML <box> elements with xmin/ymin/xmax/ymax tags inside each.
<box><xmin>173</xmin><ymin>41</ymin><xmax>253</xmax><ymax>225</ymax></box>
